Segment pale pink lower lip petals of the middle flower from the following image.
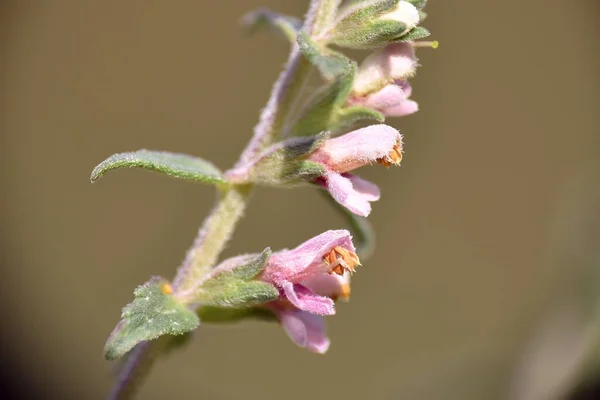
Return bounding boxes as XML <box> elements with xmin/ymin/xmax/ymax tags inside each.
<box><xmin>325</xmin><ymin>172</ymin><xmax>379</xmax><ymax>217</ymax></box>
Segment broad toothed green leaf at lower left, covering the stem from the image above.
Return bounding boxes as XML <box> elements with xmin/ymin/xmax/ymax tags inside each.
<box><xmin>104</xmin><ymin>277</ymin><xmax>200</xmax><ymax>360</ymax></box>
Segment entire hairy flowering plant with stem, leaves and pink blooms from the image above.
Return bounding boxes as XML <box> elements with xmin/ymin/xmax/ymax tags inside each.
<box><xmin>91</xmin><ymin>0</ymin><xmax>437</xmax><ymax>398</ymax></box>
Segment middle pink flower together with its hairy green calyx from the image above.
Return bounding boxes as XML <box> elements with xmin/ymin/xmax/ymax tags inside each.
<box><xmin>225</xmin><ymin>125</ymin><xmax>402</xmax><ymax>217</ymax></box>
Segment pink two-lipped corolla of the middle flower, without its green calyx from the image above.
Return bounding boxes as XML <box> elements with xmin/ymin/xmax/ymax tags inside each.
<box><xmin>308</xmin><ymin>125</ymin><xmax>402</xmax><ymax>217</ymax></box>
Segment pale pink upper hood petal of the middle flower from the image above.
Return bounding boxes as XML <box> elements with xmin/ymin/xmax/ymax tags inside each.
<box><xmin>309</xmin><ymin>124</ymin><xmax>401</xmax><ymax>173</ymax></box>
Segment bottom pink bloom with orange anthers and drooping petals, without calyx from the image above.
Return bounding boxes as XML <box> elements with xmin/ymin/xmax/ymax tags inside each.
<box><xmin>260</xmin><ymin>230</ymin><xmax>359</xmax><ymax>353</ymax></box>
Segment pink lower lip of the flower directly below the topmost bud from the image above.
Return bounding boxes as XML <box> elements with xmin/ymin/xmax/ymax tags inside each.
<box><xmin>349</xmin><ymin>80</ymin><xmax>419</xmax><ymax>117</ymax></box>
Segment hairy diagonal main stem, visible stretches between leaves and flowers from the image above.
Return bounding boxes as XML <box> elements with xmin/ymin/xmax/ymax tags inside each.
<box><xmin>109</xmin><ymin>0</ymin><xmax>339</xmax><ymax>400</ymax></box>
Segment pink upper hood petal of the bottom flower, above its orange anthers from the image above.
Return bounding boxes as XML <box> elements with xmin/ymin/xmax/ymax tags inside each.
<box><xmin>262</xmin><ymin>229</ymin><xmax>356</xmax><ymax>287</ymax></box>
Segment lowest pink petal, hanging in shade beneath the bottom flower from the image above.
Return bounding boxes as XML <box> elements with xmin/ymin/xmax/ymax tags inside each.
<box><xmin>277</xmin><ymin>310</ymin><xmax>331</xmax><ymax>354</ymax></box>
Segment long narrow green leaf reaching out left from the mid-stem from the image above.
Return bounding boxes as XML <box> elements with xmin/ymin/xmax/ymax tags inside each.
<box><xmin>90</xmin><ymin>150</ymin><xmax>227</xmax><ymax>184</ymax></box>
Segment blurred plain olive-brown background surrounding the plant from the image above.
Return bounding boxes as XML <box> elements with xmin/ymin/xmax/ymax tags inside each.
<box><xmin>0</xmin><ymin>0</ymin><xmax>600</xmax><ymax>400</ymax></box>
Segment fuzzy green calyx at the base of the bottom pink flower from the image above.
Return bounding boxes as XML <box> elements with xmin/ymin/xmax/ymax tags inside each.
<box><xmin>194</xmin><ymin>278</ymin><xmax>279</xmax><ymax>308</ymax></box>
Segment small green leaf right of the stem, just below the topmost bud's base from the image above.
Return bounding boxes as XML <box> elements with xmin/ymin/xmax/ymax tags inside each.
<box><xmin>298</xmin><ymin>32</ymin><xmax>352</xmax><ymax>81</ymax></box>
